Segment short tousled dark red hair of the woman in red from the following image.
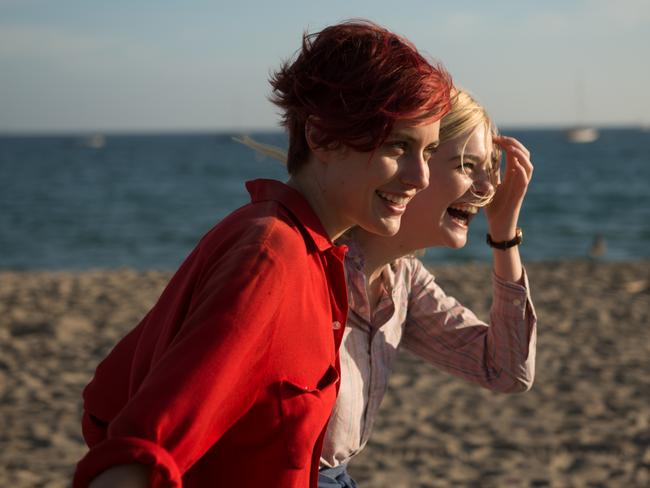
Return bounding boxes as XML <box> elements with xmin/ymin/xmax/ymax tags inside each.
<box><xmin>270</xmin><ymin>20</ymin><xmax>452</xmax><ymax>174</ymax></box>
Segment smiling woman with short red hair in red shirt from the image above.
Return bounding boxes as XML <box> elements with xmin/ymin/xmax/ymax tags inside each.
<box><xmin>74</xmin><ymin>21</ymin><xmax>451</xmax><ymax>488</ymax></box>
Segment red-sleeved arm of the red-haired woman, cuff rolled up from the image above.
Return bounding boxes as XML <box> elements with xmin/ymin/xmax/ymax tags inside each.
<box><xmin>74</xmin><ymin>245</ymin><xmax>285</xmax><ymax>488</ymax></box>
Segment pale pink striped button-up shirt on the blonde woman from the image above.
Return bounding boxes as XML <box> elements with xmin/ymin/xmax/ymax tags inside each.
<box><xmin>321</xmin><ymin>242</ymin><xmax>537</xmax><ymax>467</ymax></box>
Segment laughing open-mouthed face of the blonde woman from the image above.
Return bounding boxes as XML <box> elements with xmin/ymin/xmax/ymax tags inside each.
<box><xmin>397</xmin><ymin>124</ymin><xmax>493</xmax><ymax>252</ymax></box>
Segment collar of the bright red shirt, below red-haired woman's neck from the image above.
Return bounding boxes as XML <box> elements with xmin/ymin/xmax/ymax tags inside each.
<box><xmin>246</xmin><ymin>178</ymin><xmax>346</xmax><ymax>255</ymax></box>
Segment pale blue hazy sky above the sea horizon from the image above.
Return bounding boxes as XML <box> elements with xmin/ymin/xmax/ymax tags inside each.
<box><xmin>0</xmin><ymin>0</ymin><xmax>650</xmax><ymax>133</ymax></box>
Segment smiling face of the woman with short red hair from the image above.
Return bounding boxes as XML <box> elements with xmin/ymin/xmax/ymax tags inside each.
<box><xmin>319</xmin><ymin>121</ymin><xmax>440</xmax><ymax>236</ymax></box>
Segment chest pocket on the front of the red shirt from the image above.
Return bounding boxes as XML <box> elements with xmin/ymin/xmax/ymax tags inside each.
<box><xmin>280</xmin><ymin>366</ymin><xmax>339</xmax><ymax>469</ymax></box>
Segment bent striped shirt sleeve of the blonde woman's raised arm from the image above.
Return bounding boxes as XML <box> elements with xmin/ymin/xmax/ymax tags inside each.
<box><xmin>402</xmin><ymin>259</ymin><xmax>536</xmax><ymax>393</ymax></box>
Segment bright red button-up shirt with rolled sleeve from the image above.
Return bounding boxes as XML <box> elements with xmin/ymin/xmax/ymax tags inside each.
<box><xmin>74</xmin><ymin>180</ymin><xmax>347</xmax><ymax>488</ymax></box>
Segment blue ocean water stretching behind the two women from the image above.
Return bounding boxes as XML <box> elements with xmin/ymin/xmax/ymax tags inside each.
<box><xmin>0</xmin><ymin>129</ymin><xmax>650</xmax><ymax>270</ymax></box>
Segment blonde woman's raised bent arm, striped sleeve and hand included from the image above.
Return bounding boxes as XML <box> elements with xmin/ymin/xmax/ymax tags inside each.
<box><xmin>404</xmin><ymin>137</ymin><xmax>537</xmax><ymax>392</ymax></box>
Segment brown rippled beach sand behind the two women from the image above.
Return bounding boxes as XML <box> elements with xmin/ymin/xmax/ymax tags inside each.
<box><xmin>0</xmin><ymin>261</ymin><xmax>650</xmax><ymax>488</ymax></box>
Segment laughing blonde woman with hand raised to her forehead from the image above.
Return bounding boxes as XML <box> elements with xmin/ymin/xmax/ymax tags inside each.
<box><xmin>235</xmin><ymin>90</ymin><xmax>537</xmax><ymax>488</ymax></box>
